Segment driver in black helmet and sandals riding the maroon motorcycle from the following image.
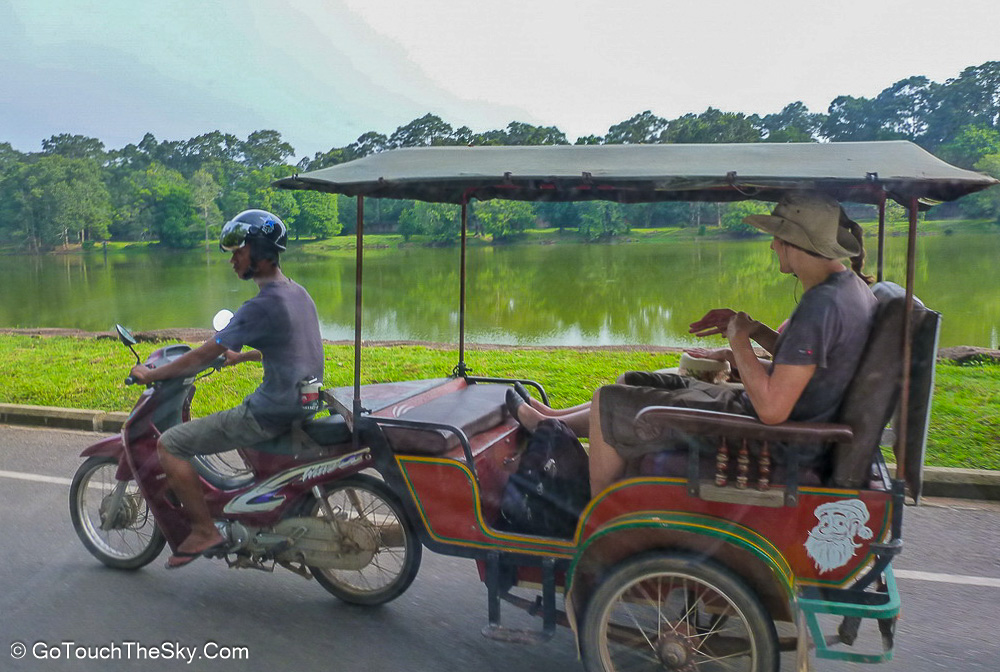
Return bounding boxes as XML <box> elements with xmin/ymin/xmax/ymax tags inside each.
<box><xmin>131</xmin><ymin>210</ymin><xmax>323</xmax><ymax>569</ymax></box>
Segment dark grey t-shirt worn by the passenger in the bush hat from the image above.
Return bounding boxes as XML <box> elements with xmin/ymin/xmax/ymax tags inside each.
<box><xmin>774</xmin><ymin>270</ymin><xmax>878</xmax><ymax>422</ymax></box>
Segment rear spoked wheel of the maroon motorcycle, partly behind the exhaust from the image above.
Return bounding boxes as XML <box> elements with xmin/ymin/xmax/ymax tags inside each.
<box><xmin>310</xmin><ymin>474</ymin><xmax>421</xmax><ymax>606</ymax></box>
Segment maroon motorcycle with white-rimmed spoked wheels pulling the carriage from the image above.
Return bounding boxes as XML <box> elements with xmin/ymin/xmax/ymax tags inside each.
<box><xmin>70</xmin><ymin>322</ymin><xmax>421</xmax><ymax>605</ymax></box>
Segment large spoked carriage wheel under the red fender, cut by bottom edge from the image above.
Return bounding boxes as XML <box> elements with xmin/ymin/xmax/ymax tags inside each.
<box><xmin>582</xmin><ymin>554</ymin><xmax>778</xmax><ymax>672</ymax></box>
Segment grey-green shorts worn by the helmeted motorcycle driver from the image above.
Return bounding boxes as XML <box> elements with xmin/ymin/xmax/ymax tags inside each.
<box><xmin>160</xmin><ymin>403</ymin><xmax>276</xmax><ymax>460</ymax></box>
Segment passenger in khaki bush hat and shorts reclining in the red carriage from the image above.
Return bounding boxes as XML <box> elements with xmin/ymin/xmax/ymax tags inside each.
<box><xmin>507</xmin><ymin>192</ymin><xmax>876</xmax><ymax>495</ymax></box>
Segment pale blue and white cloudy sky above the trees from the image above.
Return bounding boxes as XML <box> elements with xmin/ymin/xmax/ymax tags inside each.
<box><xmin>0</xmin><ymin>0</ymin><xmax>1000</xmax><ymax>157</ymax></box>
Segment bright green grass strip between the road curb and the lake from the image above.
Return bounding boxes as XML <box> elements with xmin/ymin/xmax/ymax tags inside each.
<box><xmin>0</xmin><ymin>336</ymin><xmax>1000</xmax><ymax>469</ymax></box>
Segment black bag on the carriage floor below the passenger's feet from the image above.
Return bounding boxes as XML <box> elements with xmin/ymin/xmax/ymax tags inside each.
<box><xmin>496</xmin><ymin>419</ymin><xmax>590</xmax><ymax>539</ymax></box>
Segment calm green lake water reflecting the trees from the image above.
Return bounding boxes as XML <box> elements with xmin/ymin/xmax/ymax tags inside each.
<box><xmin>0</xmin><ymin>234</ymin><xmax>1000</xmax><ymax>348</ymax></box>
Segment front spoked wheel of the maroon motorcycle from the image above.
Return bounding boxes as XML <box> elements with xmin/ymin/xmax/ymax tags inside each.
<box><xmin>69</xmin><ymin>456</ymin><xmax>166</xmax><ymax>569</ymax></box>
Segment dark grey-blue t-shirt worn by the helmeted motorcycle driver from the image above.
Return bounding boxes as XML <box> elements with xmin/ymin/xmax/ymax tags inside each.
<box><xmin>215</xmin><ymin>280</ymin><xmax>323</xmax><ymax>433</ymax></box>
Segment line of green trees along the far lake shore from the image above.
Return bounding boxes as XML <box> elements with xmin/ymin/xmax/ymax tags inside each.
<box><xmin>0</xmin><ymin>61</ymin><xmax>1000</xmax><ymax>252</ymax></box>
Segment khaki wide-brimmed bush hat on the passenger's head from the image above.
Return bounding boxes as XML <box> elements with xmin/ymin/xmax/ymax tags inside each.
<box><xmin>743</xmin><ymin>191</ymin><xmax>861</xmax><ymax>259</ymax></box>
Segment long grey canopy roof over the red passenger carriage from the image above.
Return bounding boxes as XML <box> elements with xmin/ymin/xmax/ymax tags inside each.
<box><xmin>274</xmin><ymin>141</ymin><xmax>998</xmax><ymax>208</ymax></box>
